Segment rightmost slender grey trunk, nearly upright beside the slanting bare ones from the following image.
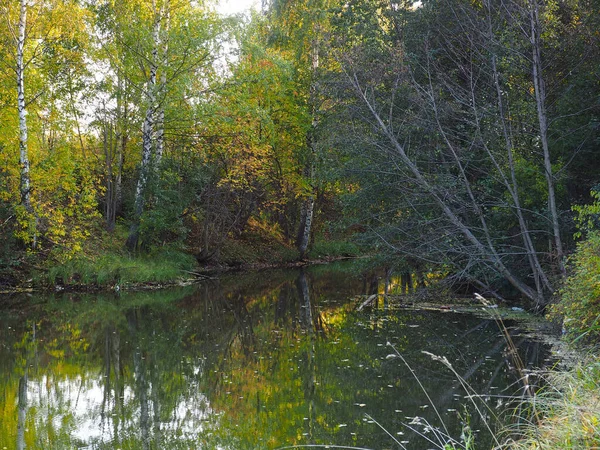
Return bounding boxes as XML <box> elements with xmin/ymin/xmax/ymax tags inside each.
<box><xmin>530</xmin><ymin>0</ymin><xmax>566</xmax><ymax>275</ymax></box>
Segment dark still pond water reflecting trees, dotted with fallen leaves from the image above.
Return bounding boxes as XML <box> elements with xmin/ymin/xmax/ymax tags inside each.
<box><xmin>0</xmin><ymin>269</ymin><xmax>549</xmax><ymax>450</ymax></box>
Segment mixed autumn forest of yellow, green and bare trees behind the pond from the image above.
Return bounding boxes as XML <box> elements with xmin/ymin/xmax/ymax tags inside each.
<box><xmin>0</xmin><ymin>0</ymin><xmax>600</xmax><ymax>320</ymax></box>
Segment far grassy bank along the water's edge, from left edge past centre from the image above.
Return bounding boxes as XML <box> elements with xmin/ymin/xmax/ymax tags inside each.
<box><xmin>0</xmin><ymin>224</ymin><xmax>360</xmax><ymax>294</ymax></box>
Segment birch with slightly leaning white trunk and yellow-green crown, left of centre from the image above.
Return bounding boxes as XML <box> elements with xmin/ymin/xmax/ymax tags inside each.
<box><xmin>97</xmin><ymin>0</ymin><xmax>219</xmax><ymax>250</ymax></box>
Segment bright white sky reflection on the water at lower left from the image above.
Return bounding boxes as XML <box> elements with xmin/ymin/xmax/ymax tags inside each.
<box><xmin>27</xmin><ymin>373</ymin><xmax>219</xmax><ymax>448</ymax></box>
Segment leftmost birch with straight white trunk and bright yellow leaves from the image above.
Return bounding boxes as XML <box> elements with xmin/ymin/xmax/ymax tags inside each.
<box><xmin>0</xmin><ymin>1</ymin><xmax>101</xmax><ymax>257</ymax></box>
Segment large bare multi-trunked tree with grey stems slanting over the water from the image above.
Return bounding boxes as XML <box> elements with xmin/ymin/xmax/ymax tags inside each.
<box><xmin>329</xmin><ymin>1</ymin><xmax>596</xmax><ymax>307</ymax></box>
